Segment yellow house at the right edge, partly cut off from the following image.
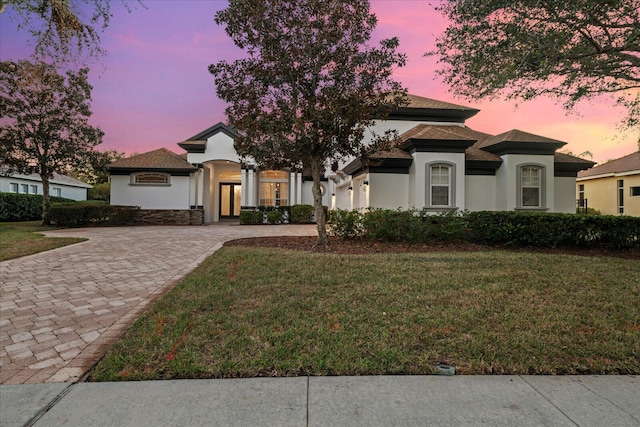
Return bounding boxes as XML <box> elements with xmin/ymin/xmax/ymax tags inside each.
<box><xmin>576</xmin><ymin>151</ymin><xmax>640</xmax><ymax>216</ymax></box>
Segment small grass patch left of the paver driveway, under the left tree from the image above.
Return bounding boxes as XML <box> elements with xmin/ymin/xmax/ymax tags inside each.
<box><xmin>0</xmin><ymin>221</ymin><xmax>87</xmax><ymax>261</ymax></box>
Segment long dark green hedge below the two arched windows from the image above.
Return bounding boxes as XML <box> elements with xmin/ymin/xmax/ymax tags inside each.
<box><xmin>330</xmin><ymin>209</ymin><xmax>640</xmax><ymax>250</ymax></box>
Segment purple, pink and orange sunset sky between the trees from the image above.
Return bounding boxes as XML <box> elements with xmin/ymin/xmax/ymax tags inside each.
<box><xmin>0</xmin><ymin>0</ymin><xmax>638</xmax><ymax>166</ymax></box>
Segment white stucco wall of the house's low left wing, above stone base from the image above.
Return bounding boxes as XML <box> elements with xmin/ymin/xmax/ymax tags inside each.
<box><xmin>111</xmin><ymin>175</ymin><xmax>190</xmax><ymax>209</ymax></box>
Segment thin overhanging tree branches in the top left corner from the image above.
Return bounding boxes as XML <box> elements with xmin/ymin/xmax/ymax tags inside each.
<box><xmin>0</xmin><ymin>0</ymin><xmax>142</xmax><ymax>63</ymax></box>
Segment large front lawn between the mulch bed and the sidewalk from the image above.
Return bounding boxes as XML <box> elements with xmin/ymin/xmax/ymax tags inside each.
<box><xmin>91</xmin><ymin>247</ymin><xmax>640</xmax><ymax>381</ymax></box>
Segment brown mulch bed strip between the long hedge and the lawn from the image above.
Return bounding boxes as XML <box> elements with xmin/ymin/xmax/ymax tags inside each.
<box><xmin>225</xmin><ymin>236</ymin><xmax>640</xmax><ymax>260</ymax></box>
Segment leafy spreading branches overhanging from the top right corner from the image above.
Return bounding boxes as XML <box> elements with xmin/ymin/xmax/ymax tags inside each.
<box><xmin>430</xmin><ymin>0</ymin><xmax>640</xmax><ymax>127</ymax></box>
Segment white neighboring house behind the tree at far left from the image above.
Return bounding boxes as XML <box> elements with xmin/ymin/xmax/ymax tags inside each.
<box><xmin>0</xmin><ymin>173</ymin><xmax>92</xmax><ymax>201</ymax></box>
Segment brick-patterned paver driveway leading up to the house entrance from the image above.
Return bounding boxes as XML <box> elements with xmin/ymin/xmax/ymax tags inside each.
<box><xmin>0</xmin><ymin>225</ymin><xmax>315</xmax><ymax>384</ymax></box>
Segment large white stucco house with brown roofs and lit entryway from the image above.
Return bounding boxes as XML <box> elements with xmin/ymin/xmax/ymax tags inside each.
<box><xmin>109</xmin><ymin>95</ymin><xmax>594</xmax><ymax>222</ymax></box>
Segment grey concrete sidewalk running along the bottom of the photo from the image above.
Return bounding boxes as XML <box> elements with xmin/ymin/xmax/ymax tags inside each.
<box><xmin>0</xmin><ymin>376</ymin><xmax>640</xmax><ymax>427</ymax></box>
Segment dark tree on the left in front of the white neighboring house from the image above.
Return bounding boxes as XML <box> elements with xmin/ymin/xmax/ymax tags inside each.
<box><xmin>0</xmin><ymin>61</ymin><xmax>104</xmax><ymax>224</ymax></box>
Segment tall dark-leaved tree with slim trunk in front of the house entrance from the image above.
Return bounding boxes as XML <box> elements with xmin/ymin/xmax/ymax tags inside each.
<box><xmin>209</xmin><ymin>0</ymin><xmax>405</xmax><ymax>245</ymax></box>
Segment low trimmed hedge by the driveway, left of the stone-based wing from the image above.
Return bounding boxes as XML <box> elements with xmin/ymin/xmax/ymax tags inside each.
<box><xmin>49</xmin><ymin>203</ymin><xmax>140</xmax><ymax>227</ymax></box>
